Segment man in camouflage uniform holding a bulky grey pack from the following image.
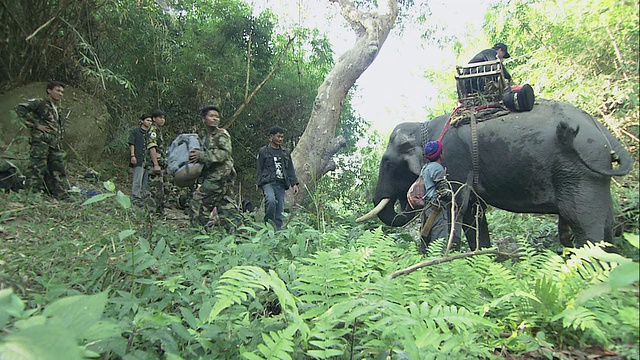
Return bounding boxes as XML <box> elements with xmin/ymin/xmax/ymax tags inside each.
<box><xmin>189</xmin><ymin>105</ymin><xmax>240</xmax><ymax>232</ymax></box>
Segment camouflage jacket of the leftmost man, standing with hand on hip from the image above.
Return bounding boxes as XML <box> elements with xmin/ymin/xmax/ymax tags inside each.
<box><xmin>16</xmin><ymin>98</ymin><xmax>66</xmax><ymax>141</ymax></box>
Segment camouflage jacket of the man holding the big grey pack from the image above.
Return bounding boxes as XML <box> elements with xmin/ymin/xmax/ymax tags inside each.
<box><xmin>198</xmin><ymin>128</ymin><xmax>236</xmax><ymax>181</ymax></box>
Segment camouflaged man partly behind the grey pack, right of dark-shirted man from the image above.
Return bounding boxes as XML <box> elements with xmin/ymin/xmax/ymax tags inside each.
<box><xmin>144</xmin><ymin>110</ymin><xmax>167</xmax><ymax>215</ymax></box>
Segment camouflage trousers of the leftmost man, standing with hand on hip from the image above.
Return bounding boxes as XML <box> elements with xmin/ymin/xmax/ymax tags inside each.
<box><xmin>26</xmin><ymin>141</ymin><xmax>69</xmax><ymax>198</ymax></box>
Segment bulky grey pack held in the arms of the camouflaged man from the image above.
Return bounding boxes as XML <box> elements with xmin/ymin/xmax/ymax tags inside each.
<box><xmin>167</xmin><ymin>134</ymin><xmax>203</xmax><ymax>187</ymax></box>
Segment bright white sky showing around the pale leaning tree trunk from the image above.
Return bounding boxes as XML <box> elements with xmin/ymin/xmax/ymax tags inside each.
<box><xmin>249</xmin><ymin>0</ymin><xmax>494</xmax><ymax>134</ymax></box>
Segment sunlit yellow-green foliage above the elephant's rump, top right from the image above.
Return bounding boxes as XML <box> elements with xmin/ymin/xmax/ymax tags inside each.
<box><xmin>485</xmin><ymin>0</ymin><xmax>640</xmax><ymax>146</ymax></box>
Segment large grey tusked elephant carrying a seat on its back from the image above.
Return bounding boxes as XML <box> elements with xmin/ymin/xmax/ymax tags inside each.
<box><xmin>357</xmin><ymin>99</ymin><xmax>633</xmax><ymax>250</ymax></box>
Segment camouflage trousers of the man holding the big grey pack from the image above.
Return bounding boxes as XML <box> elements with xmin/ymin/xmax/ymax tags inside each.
<box><xmin>189</xmin><ymin>179</ymin><xmax>241</xmax><ymax>232</ymax></box>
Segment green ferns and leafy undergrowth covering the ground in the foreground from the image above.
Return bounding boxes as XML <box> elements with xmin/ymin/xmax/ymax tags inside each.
<box><xmin>0</xmin><ymin>183</ymin><xmax>640</xmax><ymax>359</ymax></box>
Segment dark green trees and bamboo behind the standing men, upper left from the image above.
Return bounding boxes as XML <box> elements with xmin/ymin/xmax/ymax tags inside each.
<box><xmin>0</xmin><ymin>0</ymin><xmax>342</xmax><ymax>202</ymax></box>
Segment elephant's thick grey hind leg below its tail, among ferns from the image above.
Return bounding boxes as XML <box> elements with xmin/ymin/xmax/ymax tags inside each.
<box><xmin>558</xmin><ymin>179</ymin><xmax>613</xmax><ymax>247</ymax></box>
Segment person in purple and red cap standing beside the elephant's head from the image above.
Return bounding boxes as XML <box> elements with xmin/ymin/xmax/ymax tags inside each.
<box><xmin>419</xmin><ymin>140</ymin><xmax>449</xmax><ymax>253</ymax></box>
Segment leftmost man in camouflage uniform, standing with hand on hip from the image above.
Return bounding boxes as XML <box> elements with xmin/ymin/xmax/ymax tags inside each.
<box><xmin>16</xmin><ymin>81</ymin><xmax>69</xmax><ymax>199</ymax></box>
